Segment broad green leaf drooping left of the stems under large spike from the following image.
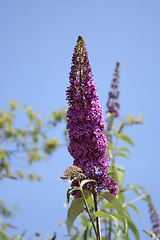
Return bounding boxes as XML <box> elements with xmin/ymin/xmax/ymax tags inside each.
<box><xmin>67</xmin><ymin>198</ymin><xmax>84</xmax><ymax>235</ymax></box>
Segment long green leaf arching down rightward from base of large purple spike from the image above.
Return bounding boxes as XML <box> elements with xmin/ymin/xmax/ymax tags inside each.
<box><xmin>100</xmin><ymin>192</ymin><xmax>127</xmax><ymax>234</ymax></box>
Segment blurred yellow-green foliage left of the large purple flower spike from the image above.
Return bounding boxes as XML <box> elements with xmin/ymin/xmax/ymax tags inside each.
<box><xmin>0</xmin><ymin>101</ymin><xmax>66</xmax><ymax>240</ymax></box>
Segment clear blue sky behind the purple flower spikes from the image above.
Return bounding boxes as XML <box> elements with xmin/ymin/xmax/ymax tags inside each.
<box><xmin>0</xmin><ymin>0</ymin><xmax>160</xmax><ymax>239</ymax></box>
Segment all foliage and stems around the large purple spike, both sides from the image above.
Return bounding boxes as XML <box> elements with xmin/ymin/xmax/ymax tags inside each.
<box><xmin>0</xmin><ymin>44</ymin><xmax>158</xmax><ymax>240</ymax></box>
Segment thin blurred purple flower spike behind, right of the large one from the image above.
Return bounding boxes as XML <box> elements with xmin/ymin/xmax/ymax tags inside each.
<box><xmin>107</xmin><ymin>62</ymin><xmax>120</xmax><ymax>117</ymax></box>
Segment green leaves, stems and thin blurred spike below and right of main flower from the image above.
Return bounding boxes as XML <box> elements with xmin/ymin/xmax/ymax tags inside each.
<box><xmin>62</xmin><ymin>59</ymin><xmax>158</xmax><ymax>240</ymax></box>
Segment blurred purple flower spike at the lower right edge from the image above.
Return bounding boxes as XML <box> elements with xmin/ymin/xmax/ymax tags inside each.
<box><xmin>148</xmin><ymin>196</ymin><xmax>160</xmax><ymax>238</ymax></box>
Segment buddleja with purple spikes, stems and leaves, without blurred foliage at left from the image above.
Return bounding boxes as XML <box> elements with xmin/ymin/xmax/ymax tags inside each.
<box><xmin>61</xmin><ymin>36</ymin><xmax>160</xmax><ymax>240</ymax></box>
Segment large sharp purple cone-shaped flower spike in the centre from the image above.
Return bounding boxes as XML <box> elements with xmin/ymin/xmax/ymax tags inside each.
<box><xmin>66</xmin><ymin>36</ymin><xmax>118</xmax><ymax>195</ymax></box>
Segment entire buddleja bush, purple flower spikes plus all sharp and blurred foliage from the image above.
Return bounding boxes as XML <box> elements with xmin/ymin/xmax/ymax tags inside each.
<box><xmin>0</xmin><ymin>36</ymin><xmax>160</xmax><ymax>240</ymax></box>
